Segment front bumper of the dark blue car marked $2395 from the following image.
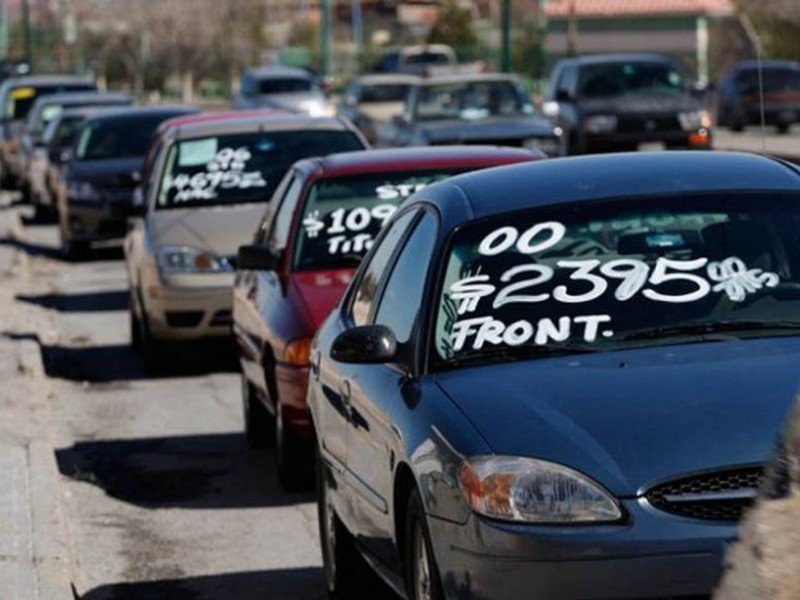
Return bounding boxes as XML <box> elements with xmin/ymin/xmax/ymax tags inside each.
<box><xmin>428</xmin><ymin>502</ymin><xmax>736</xmax><ymax>600</ymax></box>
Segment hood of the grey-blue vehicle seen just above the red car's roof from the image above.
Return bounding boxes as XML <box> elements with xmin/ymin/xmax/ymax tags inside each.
<box><xmin>417</xmin><ymin>117</ymin><xmax>555</xmax><ymax>144</ymax></box>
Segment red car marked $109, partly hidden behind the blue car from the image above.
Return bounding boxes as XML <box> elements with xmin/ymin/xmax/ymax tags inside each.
<box><xmin>233</xmin><ymin>146</ymin><xmax>544</xmax><ymax>489</ymax></box>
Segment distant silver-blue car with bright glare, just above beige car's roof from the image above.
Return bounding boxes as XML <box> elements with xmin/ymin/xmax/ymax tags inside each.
<box><xmin>231</xmin><ymin>67</ymin><xmax>336</xmax><ymax>117</ymax></box>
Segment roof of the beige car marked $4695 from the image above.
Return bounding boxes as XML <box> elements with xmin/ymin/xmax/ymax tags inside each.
<box><xmin>166</xmin><ymin>111</ymin><xmax>360</xmax><ymax>139</ymax></box>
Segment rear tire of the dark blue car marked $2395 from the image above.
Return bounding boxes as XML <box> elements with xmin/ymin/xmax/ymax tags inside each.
<box><xmin>316</xmin><ymin>452</ymin><xmax>369</xmax><ymax>600</ymax></box>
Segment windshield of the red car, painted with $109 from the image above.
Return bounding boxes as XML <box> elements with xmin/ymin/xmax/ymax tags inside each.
<box><xmin>292</xmin><ymin>168</ymin><xmax>463</xmax><ymax>271</ymax></box>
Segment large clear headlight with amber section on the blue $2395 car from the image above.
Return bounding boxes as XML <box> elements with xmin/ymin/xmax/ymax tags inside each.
<box><xmin>459</xmin><ymin>456</ymin><xmax>622</xmax><ymax>523</ymax></box>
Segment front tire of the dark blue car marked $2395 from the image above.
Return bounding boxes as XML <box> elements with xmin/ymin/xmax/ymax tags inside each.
<box><xmin>403</xmin><ymin>489</ymin><xmax>444</xmax><ymax>600</ymax></box>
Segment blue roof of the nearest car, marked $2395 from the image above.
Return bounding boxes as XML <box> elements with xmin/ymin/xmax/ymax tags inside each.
<box><xmin>410</xmin><ymin>151</ymin><xmax>800</xmax><ymax>220</ymax></box>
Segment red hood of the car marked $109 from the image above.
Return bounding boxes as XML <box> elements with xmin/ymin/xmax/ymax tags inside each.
<box><xmin>288</xmin><ymin>269</ymin><xmax>355</xmax><ymax>335</ymax></box>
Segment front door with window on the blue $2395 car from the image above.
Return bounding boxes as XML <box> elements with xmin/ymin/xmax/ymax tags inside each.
<box><xmin>347</xmin><ymin>210</ymin><xmax>438</xmax><ymax>564</ymax></box>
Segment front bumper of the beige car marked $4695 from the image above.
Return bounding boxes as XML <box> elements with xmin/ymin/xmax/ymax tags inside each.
<box><xmin>141</xmin><ymin>273</ymin><xmax>233</xmax><ymax>340</ymax></box>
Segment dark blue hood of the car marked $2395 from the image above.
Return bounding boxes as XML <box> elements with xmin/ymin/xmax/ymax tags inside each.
<box><xmin>437</xmin><ymin>338</ymin><xmax>800</xmax><ymax>497</ymax></box>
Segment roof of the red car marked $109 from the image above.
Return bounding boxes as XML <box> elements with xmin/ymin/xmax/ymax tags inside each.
<box><xmin>290</xmin><ymin>145</ymin><xmax>544</xmax><ymax>177</ymax></box>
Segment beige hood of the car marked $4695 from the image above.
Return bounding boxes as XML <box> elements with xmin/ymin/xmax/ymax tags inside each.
<box><xmin>148</xmin><ymin>203</ymin><xmax>265</xmax><ymax>257</ymax></box>
